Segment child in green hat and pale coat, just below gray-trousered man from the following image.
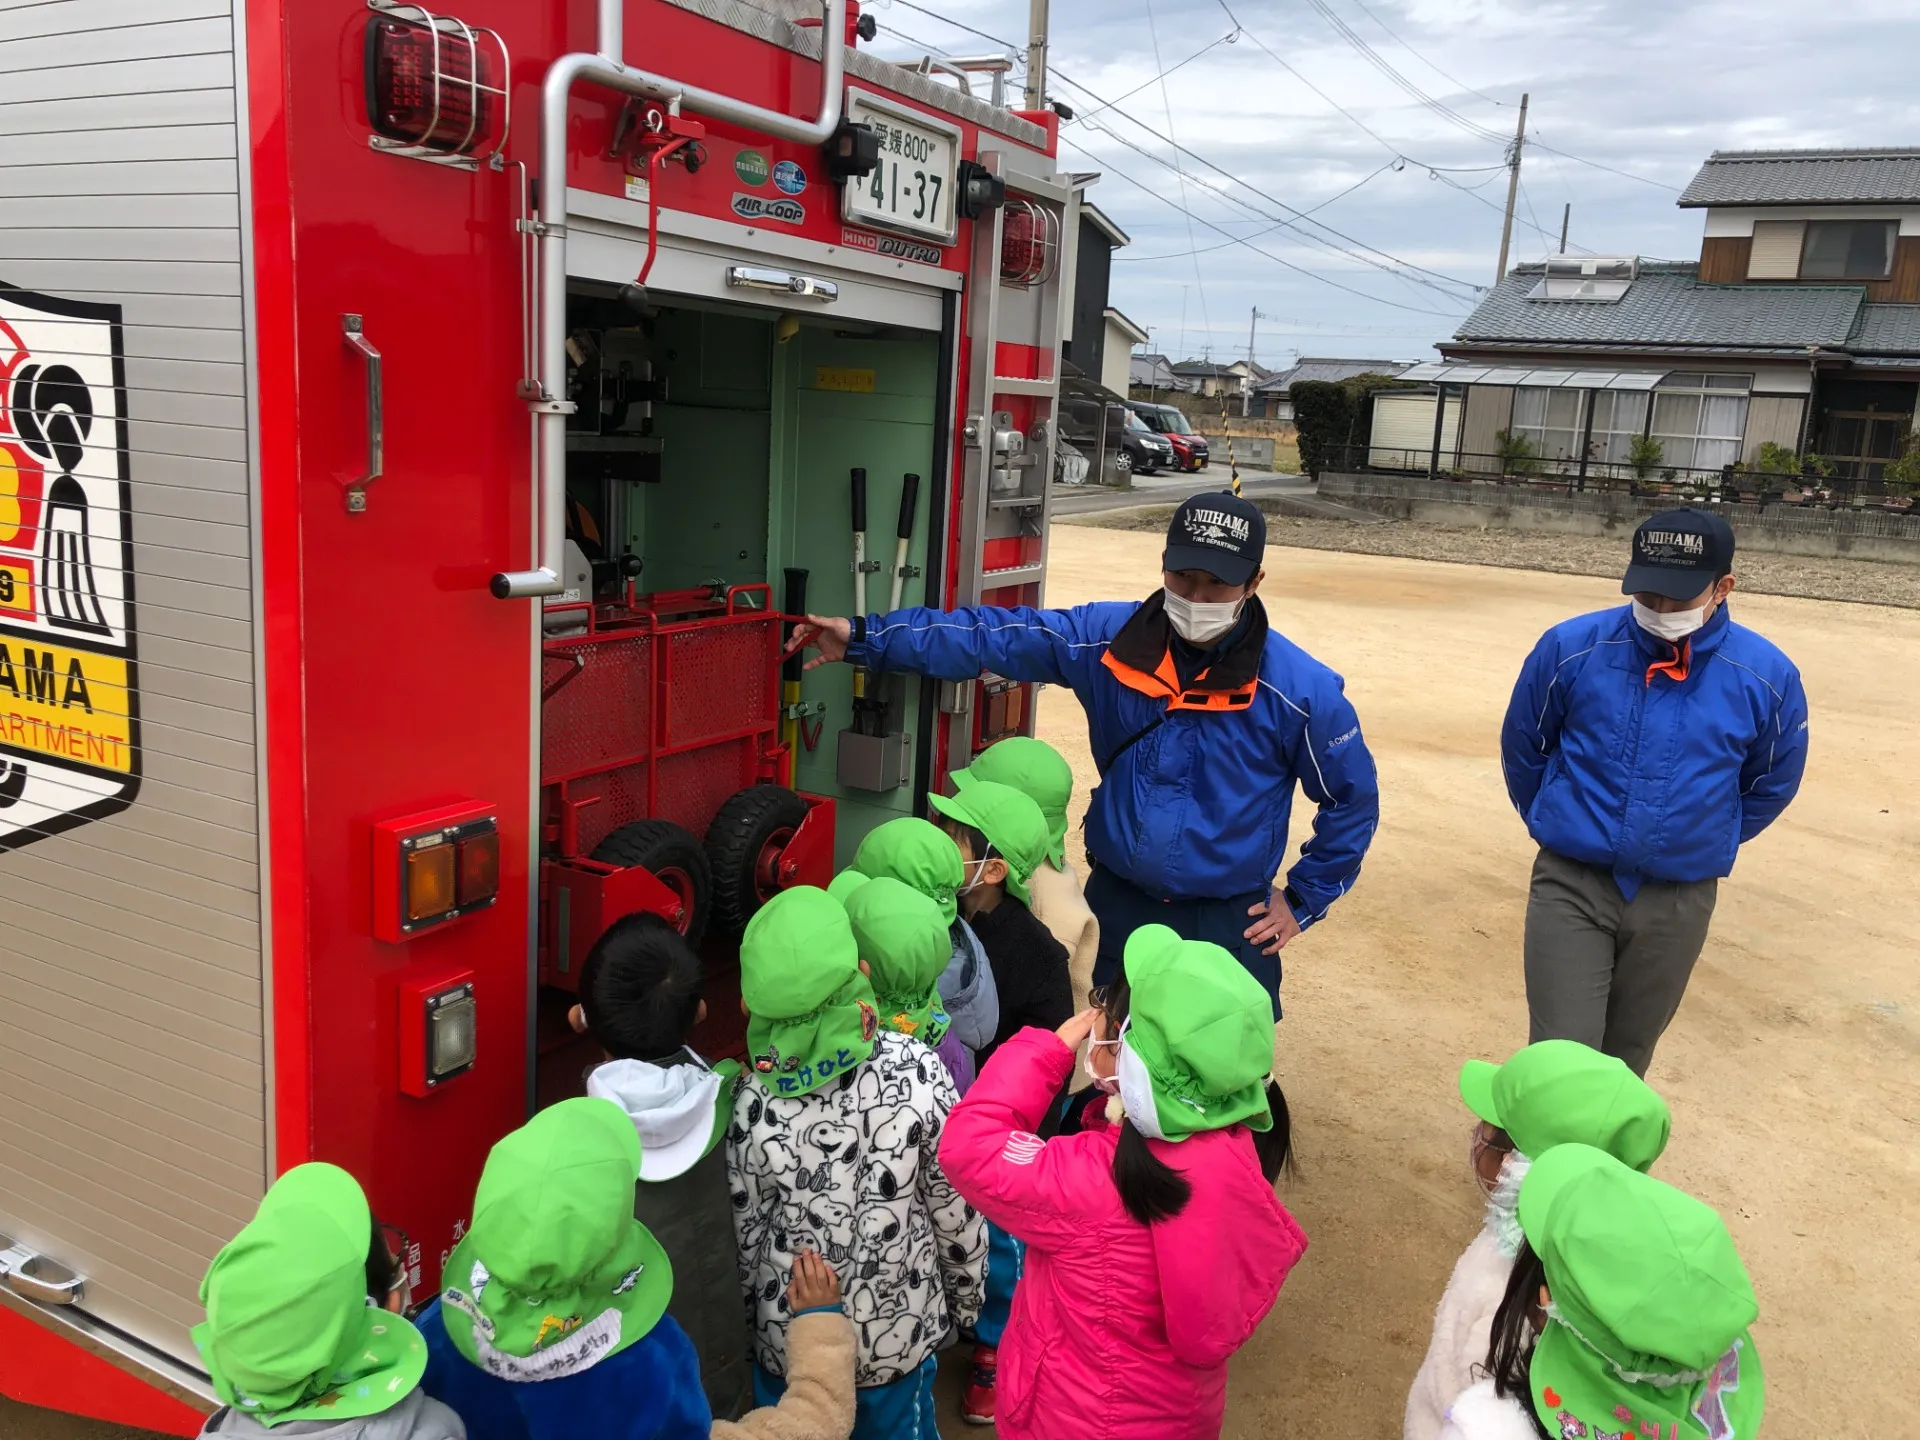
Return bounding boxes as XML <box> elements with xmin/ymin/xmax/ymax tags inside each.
<box><xmin>1404</xmin><ymin>1041</ymin><xmax>1672</xmax><ymax>1440</ymax></box>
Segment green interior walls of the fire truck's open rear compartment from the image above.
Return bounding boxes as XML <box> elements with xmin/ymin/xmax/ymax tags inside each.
<box><xmin>580</xmin><ymin>284</ymin><xmax>939</xmax><ymax>864</ymax></box>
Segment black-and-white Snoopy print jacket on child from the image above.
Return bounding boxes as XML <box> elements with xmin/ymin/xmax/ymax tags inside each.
<box><xmin>728</xmin><ymin>1031</ymin><xmax>987</xmax><ymax>1386</ymax></box>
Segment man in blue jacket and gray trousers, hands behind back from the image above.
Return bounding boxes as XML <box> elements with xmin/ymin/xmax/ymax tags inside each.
<box><xmin>1500</xmin><ymin>511</ymin><xmax>1807</xmax><ymax>1075</ymax></box>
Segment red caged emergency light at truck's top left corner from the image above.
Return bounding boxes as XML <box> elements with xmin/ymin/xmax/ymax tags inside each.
<box><xmin>367</xmin><ymin>0</ymin><xmax>507</xmax><ymax>163</ymax></box>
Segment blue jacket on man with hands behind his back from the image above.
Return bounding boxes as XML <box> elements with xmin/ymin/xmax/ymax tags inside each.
<box><xmin>1500</xmin><ymin>605</ymin><xmax>1807</xmax><ymax>899</ymax></box>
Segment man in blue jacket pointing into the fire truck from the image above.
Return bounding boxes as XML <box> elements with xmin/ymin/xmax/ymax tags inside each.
<box><xmin>791</xmin><ymin>493</ymin><xmax>1380</xmax><ymax>1020</ymax></box>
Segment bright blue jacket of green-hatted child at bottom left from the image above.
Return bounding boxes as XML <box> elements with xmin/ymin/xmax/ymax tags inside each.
<box><xmin>419</xmin><ymin>1300</ymin><xmax>714</xmax><ymax>1440</ymax></box>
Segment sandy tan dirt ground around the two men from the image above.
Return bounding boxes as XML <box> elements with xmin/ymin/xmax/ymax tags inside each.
<box><xmin>18</xmin><ymin>526</ymin><xmax>1920</xmax><ymax>1440</ymax></box>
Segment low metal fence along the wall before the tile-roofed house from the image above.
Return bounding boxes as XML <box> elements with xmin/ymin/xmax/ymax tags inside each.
<box><xmin>1323</xmin><ymin>444</ymin><xmax>1914</xmax><ymax>513</ymax></box>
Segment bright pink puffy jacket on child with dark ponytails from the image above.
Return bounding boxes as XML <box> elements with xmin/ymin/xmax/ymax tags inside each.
<box><xmin>941</xmin><ymin>1029</ymin><xmax>1308</xmax><ymax>1440</ymax></box>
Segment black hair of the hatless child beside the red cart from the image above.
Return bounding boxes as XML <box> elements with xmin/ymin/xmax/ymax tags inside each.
<box><xmin>580</xmin><ymin>914</ymin><xmax>705</xmax><ymax>1060</ymax></box>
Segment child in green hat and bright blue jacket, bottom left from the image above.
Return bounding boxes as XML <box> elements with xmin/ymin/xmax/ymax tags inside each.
<box><xmin>420</xmin><ymin>1096</ymin><xmax>712</xmax><ymax>1440</ymax></box>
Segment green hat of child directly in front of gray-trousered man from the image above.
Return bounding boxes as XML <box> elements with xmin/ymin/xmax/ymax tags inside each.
<box><xmin>1459</xmin><ymin>1041</ymin><xmax>1672</xmax><ymax>1169</ymax></box>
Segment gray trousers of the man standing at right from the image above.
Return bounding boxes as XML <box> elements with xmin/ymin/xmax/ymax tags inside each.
<box><xmin>1526</xmin><ymin>849</ymin><xmax>1720</xmax><ymax>1075</ymax></box>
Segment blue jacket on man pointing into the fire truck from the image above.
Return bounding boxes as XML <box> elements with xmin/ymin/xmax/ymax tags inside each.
<box><xmin>849</xmin><ymin>601</ymin><xmax>1380</xmax><ymax>925</ymax></box>
